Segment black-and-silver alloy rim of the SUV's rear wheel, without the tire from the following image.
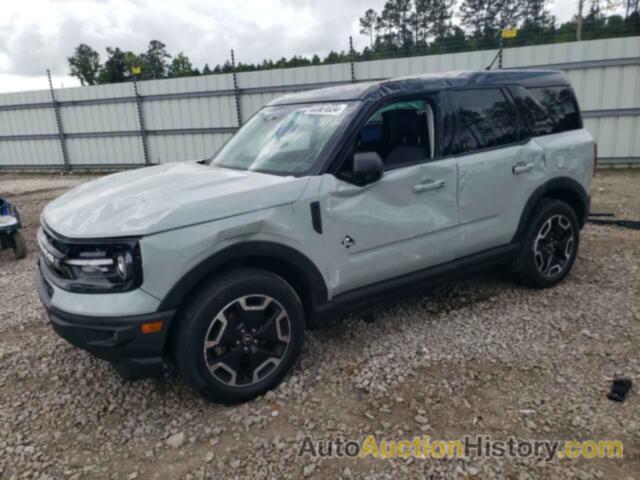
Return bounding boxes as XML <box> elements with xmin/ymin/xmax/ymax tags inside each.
<box><xmin>533</xmin><ymin>215</ymin><xmax>575</xmax><ymax>277</ymax></box>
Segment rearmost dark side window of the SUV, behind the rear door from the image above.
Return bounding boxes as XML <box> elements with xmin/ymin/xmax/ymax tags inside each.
<box><xmin>527</xmin><ymin>86</ymin><xmax>582</xmax><ymax>135</ymax></box>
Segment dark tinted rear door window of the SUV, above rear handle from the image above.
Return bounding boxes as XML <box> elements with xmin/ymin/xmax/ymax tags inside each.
<box><xmin>449</xmin><ymin>88</ymin><xmax>522</xmax><ymax>155</ymax></box>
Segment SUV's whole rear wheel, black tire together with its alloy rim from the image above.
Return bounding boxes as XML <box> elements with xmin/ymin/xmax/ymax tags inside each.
<box><xmin>512</xmin><ymin>199</ymin><xmax>580</xmax><ymax>288</ymax></box>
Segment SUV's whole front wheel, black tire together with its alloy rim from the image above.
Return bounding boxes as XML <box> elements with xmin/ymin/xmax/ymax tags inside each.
<box><xmin>173</xmin><ymin>268</ymin><xmax>305</xmax><ymax>404</ymax></box>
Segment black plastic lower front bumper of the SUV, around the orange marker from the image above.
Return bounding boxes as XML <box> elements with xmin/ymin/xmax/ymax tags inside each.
<box><xmin>38</xmin><ymin>264</ymin><xmax>175</xmax><ymax>380</ymax></box>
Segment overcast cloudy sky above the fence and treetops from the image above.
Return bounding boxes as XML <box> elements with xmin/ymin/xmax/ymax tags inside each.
<box><xmin>0</xmin><ymin>0</ymin><xmax>592</xmax><ymax>92</ymax></box>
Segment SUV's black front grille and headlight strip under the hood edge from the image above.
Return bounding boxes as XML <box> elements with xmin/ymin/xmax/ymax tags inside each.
<box><xmin>38</xmin><ymin>229</ymin><xmax>142</xmax><ymax>293</ymax></box>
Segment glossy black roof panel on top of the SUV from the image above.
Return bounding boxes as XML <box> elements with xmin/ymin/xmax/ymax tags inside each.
<box><xmin>268</xmin><ymin>70</ymin><xmax>569</xmax><ymax>105</ymax></box>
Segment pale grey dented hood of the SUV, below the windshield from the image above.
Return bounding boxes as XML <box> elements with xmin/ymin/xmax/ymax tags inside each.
<box><xmin>43</xmin><ymin>162</ymin><xmax>308</xmax><ymax>238</ymax></box>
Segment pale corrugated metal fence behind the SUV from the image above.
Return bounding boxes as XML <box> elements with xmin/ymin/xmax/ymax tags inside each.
<box><xmin>0</xmin><ymin>37</ymin><xmax>640</xmax><ymax>169</ymax></box>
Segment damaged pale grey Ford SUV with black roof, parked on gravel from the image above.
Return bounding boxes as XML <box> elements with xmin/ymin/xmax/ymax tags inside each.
<box><xmin>38</xmin><ymin>70</ymin><xmax>596</xmax><ymax>403</ymax></box>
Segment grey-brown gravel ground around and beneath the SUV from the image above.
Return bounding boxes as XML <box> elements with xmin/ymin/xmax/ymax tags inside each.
<box><xmin>0</xmin><ymin>171</ymin><xmax>640</xmax><ymax>480</ymax></box>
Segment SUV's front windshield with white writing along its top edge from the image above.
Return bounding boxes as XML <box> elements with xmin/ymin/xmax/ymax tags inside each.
<box><xmin>211</xmin><ymin>102</ymin><xmax>357</xmax><ymax>175</ymax></box>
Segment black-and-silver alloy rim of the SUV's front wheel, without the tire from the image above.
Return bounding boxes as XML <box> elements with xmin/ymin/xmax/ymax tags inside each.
<box><xmin>203</xmin><ymin>294</ymin><xmax>291</xmax><ymax>387</ymax></box>
